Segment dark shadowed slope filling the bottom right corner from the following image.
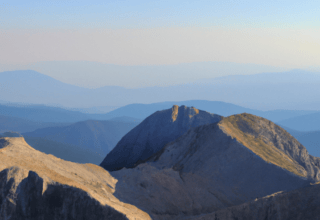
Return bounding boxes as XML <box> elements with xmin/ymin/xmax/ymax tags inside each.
<box><xmin>194</xmin><ymin>185</ymin><xmax>320</xmax><ymax>220</ymax></box>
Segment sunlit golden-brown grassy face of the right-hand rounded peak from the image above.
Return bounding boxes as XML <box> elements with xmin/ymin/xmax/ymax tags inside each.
<box><xmin>219</xmin><ymin>113</ymin><xmax>320</xmax><ymax>180</ymax></box>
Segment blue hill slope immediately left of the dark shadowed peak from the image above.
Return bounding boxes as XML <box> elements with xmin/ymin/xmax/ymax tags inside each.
<box><xmin>22</xmin><ymin>120</ymin><xmax>138</xmax><ymax>157</ymax></box>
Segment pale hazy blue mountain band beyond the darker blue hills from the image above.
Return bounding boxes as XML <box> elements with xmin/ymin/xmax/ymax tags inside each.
<box><xmin>0</xmin><ymin>70</ymin><xmax>320</xmax><ymax>110</ymax></box>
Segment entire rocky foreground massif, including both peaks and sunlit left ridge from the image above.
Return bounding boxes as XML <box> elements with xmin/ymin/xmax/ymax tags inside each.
<box><xmin>0</xmin><ymin>106</ymin><xmax>320</xmax><ymax>220</ymax></box>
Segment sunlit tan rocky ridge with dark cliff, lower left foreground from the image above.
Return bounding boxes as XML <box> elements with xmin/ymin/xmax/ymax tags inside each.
<box><xmin>0</xmin><ymin>138</ymin><xmax>150</xmax><ymax>220</ymax></box>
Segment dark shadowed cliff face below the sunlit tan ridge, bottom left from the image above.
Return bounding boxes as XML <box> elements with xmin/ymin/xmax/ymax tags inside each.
<box><xmin>0</xmin><ymin>167</ymin><xmax>128</xmax><ymax>220</ymax></box>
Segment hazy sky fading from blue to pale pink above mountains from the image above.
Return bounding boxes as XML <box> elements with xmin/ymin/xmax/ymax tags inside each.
<box><xmin>0</xmin><ymin>0</ymin><xmax>320</xmax><ymax>87</ymax></box>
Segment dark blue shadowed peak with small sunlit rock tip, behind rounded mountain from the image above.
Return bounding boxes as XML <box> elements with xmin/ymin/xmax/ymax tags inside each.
<box><xmin>100</xmin><ymin>105</ymin><xmax>222</xmax><ymax>171</ymax></box>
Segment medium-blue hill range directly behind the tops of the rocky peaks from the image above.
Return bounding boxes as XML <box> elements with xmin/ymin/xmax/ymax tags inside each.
<box><xmin>0</xmin><ymin>100</ymin><xmax>320</xmax><ymax>132</ymax></box>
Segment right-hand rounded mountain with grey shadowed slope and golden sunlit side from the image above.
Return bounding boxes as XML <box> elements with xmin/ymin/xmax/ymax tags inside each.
<box><xmin>111</xmin><ymin>114</ymin><xmax>320</xmax><ymax>219</ymax></box>
